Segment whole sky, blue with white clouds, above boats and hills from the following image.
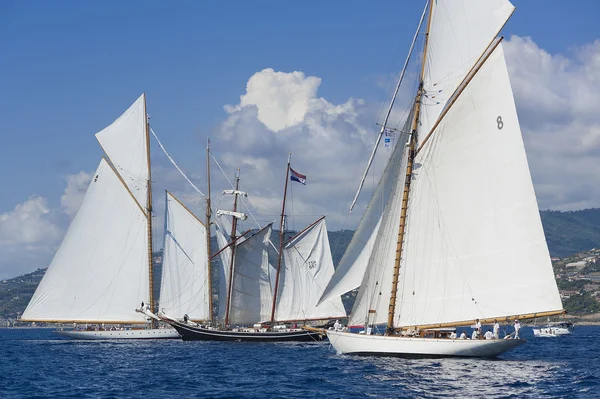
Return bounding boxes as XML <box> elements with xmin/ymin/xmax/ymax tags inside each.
<box><xmin>0</xmin><ymin>0</ymin><xmax>600</xmax><ymax>279</ymax></box>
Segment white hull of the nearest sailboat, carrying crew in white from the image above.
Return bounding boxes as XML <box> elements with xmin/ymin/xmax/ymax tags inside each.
<box><xmin>327</xmin><ymin>330</ymin><xmax>525</xmax><ymax>358</ymax></box>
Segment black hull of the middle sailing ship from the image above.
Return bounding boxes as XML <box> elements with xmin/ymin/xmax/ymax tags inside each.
<box><xmin>170</xmin><ymin>321</ymin><xmax>325</xmax><ymax>342</ymax></box>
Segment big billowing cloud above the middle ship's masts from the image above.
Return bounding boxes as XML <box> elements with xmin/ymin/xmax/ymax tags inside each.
<box><xmin>216</xmin><ymin>69</ymin><xmax>387</xmax><ymax>233</ymax></box>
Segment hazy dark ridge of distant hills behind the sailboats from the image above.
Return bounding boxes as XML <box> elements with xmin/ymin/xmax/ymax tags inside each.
<box><xmin>0</xmin><ymin>208</ymin><xmax>600</xmax><ymax>318</ymax></box>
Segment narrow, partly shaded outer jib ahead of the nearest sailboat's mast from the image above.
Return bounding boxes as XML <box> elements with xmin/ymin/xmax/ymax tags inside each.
<box><xmin>319</xmin><ymin>117</ymin><xmax>412</xmax><ymax>303</ymax></box>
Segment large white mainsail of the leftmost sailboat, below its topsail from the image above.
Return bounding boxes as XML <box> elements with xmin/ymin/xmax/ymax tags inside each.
<box><xmin>22</xmin><ymin>159</ymin><xmax>149</xmax><ymax>323</ymax></box>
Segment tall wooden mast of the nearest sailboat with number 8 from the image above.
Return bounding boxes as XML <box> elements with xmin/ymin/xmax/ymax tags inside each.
<box><xmin>386</xmin><ymin>2</ymin><xmax>433</xmax><ymax>334</ymax></box>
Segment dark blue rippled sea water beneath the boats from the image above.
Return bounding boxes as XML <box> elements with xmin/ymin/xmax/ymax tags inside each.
<box><xmin>0</xmin><ymin>326</ymin><xmax>600</xmax><ymax>399</ymax></box>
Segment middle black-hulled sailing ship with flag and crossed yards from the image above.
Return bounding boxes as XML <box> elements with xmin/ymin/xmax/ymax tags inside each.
<box><xmin>164</xmin><ymin>153</ymin><xmax>345</xmax><ymax>342</ymax></box>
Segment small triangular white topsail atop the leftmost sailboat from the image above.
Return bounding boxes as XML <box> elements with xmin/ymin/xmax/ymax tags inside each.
<box><xmin>96</xmin><ymin>94</ymin><xmax>149</xmax><ymax>209</ymax></box>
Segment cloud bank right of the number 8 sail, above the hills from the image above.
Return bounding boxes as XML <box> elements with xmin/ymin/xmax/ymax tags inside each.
<box><xmin>504</xmin><ymin>36</ymin><xmax>600</xmax><ymax>210</ymax></box>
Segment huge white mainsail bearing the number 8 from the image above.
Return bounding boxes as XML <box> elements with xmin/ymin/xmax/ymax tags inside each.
<box><xmin>394</xmin><ymin>45</ymin><xmax>562</xmax><ymax>326</ymax></box>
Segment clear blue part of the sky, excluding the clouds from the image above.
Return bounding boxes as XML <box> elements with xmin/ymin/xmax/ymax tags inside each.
<box><xmin>0</xmin><ymin>0</ymin><xmax>600</xmax><ymax>277</ymax></box>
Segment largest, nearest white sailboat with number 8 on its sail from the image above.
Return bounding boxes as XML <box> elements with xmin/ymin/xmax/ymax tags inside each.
<box><xmin>322</xmin><ymin>0</ymin><xmax>564</xmax><ymax>357</ymax></box>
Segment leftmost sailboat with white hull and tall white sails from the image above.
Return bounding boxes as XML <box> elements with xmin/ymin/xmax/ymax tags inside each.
<box><xmin>21</xmin><ymin>94</ymin><xmax>179</xmax><ymax>339</ymax></box>
